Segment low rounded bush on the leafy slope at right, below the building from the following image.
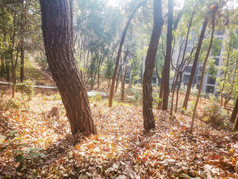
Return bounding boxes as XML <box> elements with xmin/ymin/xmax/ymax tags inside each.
<box><xmin>203</xmin><ymin>103</ymin><xmax>233</xmax><ymax>130</ymax></box>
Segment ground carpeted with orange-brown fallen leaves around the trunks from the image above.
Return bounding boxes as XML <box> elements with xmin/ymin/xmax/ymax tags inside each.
<box><xmin>0</xmin><ymin>94</ymin><xmax>238</xmax><ymax>179</ymax></box>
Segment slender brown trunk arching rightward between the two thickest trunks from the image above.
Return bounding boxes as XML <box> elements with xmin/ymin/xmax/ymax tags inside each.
<box><xmin>109</xmin><ymin>1</ymin><xmax>145</xmax><ymax>107</ymax></box>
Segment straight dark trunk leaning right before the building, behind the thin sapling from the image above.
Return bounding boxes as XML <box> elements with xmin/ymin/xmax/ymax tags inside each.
<box><xmin>183</xmin><ymin>18</ymin><xmax>209</xmax><ymax>110</ymax></box>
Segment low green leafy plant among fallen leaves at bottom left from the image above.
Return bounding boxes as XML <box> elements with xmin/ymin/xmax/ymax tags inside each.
<box><xmin>0</xmin><ymin>131</ymin><xmax>45</xmax><ymax>171</ymax></box>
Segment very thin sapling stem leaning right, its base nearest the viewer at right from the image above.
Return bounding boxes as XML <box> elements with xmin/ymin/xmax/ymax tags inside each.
<box><xmin>190</xmin><ymin>4</ymin><xmax>218</xmax><ymax>132</ymax></box>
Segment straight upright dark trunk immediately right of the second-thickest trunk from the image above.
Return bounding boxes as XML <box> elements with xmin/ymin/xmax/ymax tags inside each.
<box><xmin>162</xmin><ymin>0</ymin><xmax>174</xmax><ymax>111</ymax></box>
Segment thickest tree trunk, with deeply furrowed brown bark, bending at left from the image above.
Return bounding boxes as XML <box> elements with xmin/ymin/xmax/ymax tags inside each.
<box><xmin>40</xmin><ymin>0</ymin><xmax>96</xmax><ymax>135</ymax></box>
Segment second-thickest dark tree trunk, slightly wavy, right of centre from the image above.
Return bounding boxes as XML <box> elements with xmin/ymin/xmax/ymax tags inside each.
<box><xmin>143</xmin><ymin>0</ymin><xmax>163</xmax><ymax>131</ymax></box>
